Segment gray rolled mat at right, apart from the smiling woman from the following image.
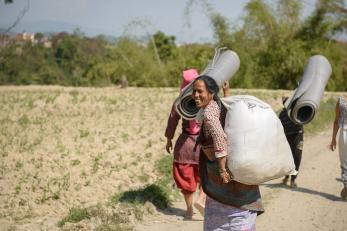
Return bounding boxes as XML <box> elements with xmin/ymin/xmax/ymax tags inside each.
<box><xmin>284</xmin><ymin>55</ymin><xmax>331</xmax><ymax>125</ymax></box>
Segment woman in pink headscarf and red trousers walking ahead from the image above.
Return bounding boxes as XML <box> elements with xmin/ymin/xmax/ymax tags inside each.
<box><xmin>165</xmin><ymin>69</ymin><xmax>205</xmax><ymax>219</ymax></box>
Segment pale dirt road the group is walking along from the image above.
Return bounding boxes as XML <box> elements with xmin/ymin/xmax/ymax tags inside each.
<box><xmin>135</xmin><ymin>130</ymin><xmax>347</xmax><ymax>231</ymax></box>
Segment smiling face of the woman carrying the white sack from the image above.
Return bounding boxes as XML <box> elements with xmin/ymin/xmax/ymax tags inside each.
<box><xmin>192</xmin><ymin>80</ymin><xmax>213</xmax><ymax>108</ymax></box>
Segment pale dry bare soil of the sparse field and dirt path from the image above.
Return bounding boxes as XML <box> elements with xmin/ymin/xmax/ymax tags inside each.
<box><xmin>0</xmin><ymin>86</ymin><xmax>347</xmax><ymax>231</ymax></box>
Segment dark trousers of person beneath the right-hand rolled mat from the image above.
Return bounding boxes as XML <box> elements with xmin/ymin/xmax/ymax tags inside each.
<box><xmin>286</xmin><ymin>133</ymin><xmax>304</xmax><ymax>180</ymax></box>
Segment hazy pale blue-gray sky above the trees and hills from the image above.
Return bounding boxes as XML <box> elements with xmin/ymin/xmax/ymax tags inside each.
<box><xmin>0</xmin><ymin>0</ymin><xmax>315</xmax><ymax>42</ymax></box>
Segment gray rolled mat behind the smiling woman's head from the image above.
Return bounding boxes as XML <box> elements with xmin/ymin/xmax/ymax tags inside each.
<box><xmin>175</xmin><ymin>48</ymin><xmax>240</xmax><ymax>120</ymax></box>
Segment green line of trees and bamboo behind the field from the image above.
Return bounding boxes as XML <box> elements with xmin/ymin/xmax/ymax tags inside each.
<box><xmin>0</xmin><ymin>0</ymin><xmax>347</xmax><ymax>91</ymax></box>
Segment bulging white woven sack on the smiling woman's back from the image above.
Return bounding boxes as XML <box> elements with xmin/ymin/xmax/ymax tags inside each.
<box><xmin>222</xmin><ymin>95</ymin><xmax>296</xmax><ymax>185</ymax></box>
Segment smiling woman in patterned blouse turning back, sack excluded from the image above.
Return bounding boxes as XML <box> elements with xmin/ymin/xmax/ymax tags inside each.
<box><xmin>192</xmin><ymin>76</ymin><xmax>264</xmax><ymax>231</ymax></box>
